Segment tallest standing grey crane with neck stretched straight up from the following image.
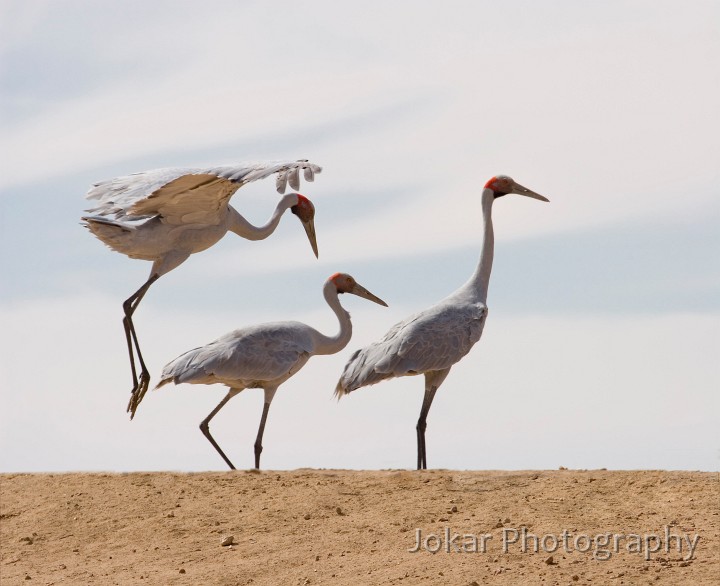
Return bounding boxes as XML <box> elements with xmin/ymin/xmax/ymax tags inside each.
<box><xmin>335</xmin><ymin>175</ymin><xmax>549</xmax><ymax>470</ymax></box>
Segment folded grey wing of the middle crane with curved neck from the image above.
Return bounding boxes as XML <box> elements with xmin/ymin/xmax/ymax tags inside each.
<box><xmin>162</xmin><ymin>322</ymin><xmax>312</xmax><ymax>386</ymax></box>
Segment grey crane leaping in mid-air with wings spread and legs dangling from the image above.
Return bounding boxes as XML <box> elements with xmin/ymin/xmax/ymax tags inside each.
<box><xmin>82</xmin><ymin>160</ymin><xmax>322</xmax><ymax>419</ymax></box>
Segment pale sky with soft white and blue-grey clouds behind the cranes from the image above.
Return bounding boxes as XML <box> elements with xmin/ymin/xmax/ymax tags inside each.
<box><xmin>0</xmin><ymin>0</ymin><xmax>720</xmax><ymax>471</ymax></box>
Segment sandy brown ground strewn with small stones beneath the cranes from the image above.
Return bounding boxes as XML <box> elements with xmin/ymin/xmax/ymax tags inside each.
<box><xmin>0</xmin><ymin>470</ymin><xmax>720</xmax><ymax>585</ymax></box>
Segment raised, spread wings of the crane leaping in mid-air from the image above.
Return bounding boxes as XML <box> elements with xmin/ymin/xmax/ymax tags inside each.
<box><xmin>86</xmin><ymin>160</ymin><xmax>322</xmax><ymax>225</ymax></box>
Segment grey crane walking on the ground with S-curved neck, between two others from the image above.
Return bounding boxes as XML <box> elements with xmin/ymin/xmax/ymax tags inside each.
<box><xmin>155</xmin><ymin>273</ymin><xmax>387</xmax><ymax>470</ymax></box>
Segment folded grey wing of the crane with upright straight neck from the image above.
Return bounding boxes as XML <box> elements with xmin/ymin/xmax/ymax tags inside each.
<box><xmin>338</xmin><ymin>303</ymin><xmax>487</xmax><ymax>393</ymax></box>
